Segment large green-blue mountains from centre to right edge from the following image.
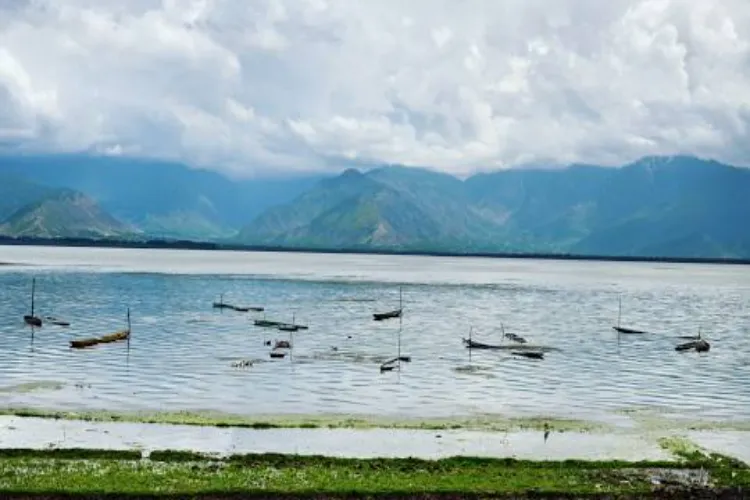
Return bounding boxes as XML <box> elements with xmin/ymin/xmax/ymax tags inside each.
<box><xmin>238</xmin><ymin>156</ymin><xmax>750</xmax><ymax>258</ymax></box>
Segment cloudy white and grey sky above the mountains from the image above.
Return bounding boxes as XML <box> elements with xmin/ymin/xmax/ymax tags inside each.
<box><xmin>0</xmin><ymin>0</ymin><xmax>750</xmax><ymax>176</ymax></box>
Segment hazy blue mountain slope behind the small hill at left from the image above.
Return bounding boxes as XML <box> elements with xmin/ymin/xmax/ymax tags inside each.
<box><xmin>0</xmin><ymin>154</ymin><xmax>322</xmax><ymax>241</ymax></box>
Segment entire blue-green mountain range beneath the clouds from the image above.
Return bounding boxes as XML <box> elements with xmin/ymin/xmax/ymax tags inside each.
<box><xmin>0</xmin><ymin>155</ymin><xmax>750</xmax><ymax>258</ymax></box>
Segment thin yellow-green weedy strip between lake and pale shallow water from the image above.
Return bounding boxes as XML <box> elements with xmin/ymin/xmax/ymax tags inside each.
<box><xmin>0</xmin><ymin>408</ymin><xmax>607</xmax><ymax>432</ymax></box>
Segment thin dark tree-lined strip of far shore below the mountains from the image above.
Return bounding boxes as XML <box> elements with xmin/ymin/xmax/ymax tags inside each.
<box><xmin>0</xmin><ymin>236</ymin><xmax>750</xmax><ymax>265</ymax></box>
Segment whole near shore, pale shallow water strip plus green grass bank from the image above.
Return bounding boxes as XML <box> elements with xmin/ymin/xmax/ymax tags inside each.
<box><xmin>0</xmin><ymin>416</ymin><xmax>750</xmax><ymax>499</ymax></box>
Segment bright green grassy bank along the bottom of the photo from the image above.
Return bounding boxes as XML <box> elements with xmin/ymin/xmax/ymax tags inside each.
<box><xmin>0</xmin><ymin>449</ymin><xmax>750</xmax><ymax>498</ymax></box>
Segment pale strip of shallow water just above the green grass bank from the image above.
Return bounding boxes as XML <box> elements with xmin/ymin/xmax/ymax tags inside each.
<box><xmin>0</xmin><ymin>414</ymin><xmax>750</xmax><ymax>463</ymax></box>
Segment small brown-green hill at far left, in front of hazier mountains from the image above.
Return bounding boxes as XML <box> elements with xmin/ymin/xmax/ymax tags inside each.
<box><xmin>0</xmin><ymin>189</ymin><xmax>137</xmax><ymax>239</ymax></box>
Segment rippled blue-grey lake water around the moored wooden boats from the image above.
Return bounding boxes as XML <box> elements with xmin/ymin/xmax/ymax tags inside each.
<box><xmin>0</xmin><ymin>247</ymin><xmax>750</xmax><ymax>421</ymax></box>
